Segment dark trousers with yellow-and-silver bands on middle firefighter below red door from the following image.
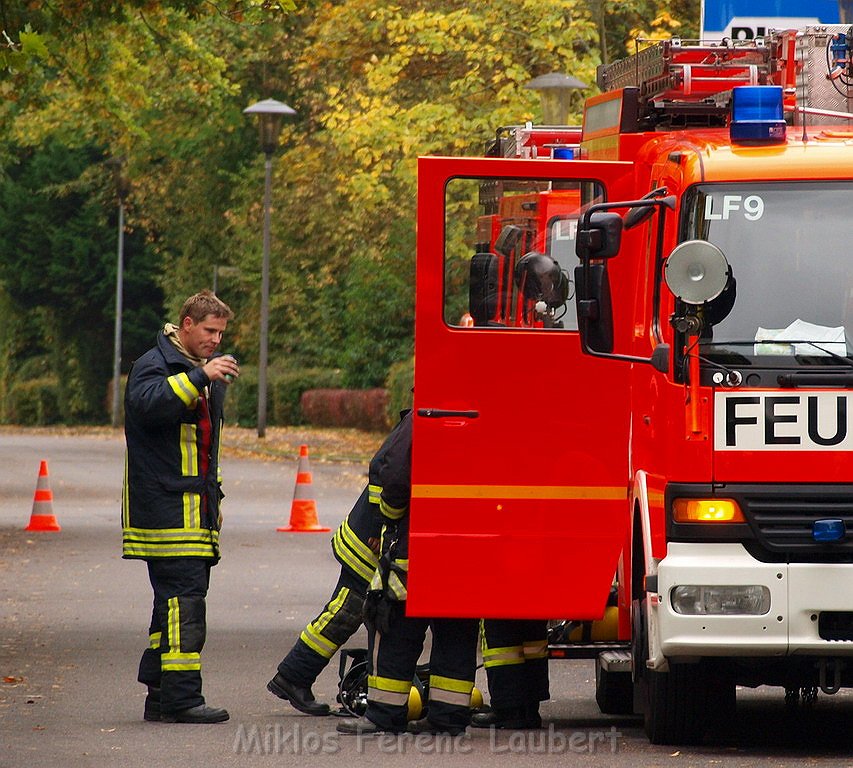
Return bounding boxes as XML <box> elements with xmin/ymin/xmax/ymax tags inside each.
<box><xmin>365</xmin><ymin>603</ymin><xmax>479</xmax><ymax>733</ymax></box>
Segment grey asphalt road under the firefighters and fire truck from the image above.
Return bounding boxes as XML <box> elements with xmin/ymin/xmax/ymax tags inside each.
<box><xmin>0</xmin><ymin>433</ymin><xmax>853</xmax><ymax>768</ymax></box>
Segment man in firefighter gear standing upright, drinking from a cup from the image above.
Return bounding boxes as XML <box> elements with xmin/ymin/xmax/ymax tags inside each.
<box><xmin>122</xmin><ymin>291</ymin><xmax>240</xmax><ymax>723</ymax></box>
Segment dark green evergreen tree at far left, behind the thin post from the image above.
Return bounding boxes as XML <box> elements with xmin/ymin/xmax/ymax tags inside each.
<box><xmin>0</xmin><ymin>141</ymin><xmax>161</xmax><ymax>421</ymax></box>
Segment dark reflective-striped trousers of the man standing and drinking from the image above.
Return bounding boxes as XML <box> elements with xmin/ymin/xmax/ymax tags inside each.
<box><xmin>138</xmin><ymin>557</ymin><xmax>214</xmax><ymax>714</ymax></box>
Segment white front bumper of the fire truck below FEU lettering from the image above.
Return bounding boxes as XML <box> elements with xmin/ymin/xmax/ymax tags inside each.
<box><xmin>650</xmin><ymin>543</ymin><xmax>853</xmax><ymax>666</ymax></box>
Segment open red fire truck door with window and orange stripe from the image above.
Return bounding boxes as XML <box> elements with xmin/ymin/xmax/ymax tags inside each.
<box><xmin>407</xmin><ymin>158</ymin><xmax>629</xmax><ymax>619</ymax></box>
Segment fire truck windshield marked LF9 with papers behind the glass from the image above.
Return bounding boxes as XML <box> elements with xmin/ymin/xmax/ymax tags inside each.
<box><xmin>682</xmin><ymin>181</ymin><xmax>853</xmax><ymax>366</ymax></box>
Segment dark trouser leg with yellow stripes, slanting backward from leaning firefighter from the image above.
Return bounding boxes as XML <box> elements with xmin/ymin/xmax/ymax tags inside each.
<box><xmin>278</xmin><ymin>568</ymin><xmax>367</xmax><ymax>688</ymax></box>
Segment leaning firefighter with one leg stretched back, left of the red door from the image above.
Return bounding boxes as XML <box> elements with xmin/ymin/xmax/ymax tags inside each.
<box><xmin>267</xmin><ymin>486</ymin><xmax>381</xmax><ymax>715</ymax></box>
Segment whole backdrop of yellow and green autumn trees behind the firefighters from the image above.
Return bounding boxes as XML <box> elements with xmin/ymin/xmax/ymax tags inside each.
<box><xmin>0</xmin><ymin>0</ymin><xmax>699</xmax><ymax>423</ymax></box>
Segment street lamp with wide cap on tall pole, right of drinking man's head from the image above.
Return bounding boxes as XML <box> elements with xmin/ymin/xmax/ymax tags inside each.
<box><xmin>243</xmin><ymin>99</ymin><xmax>296</xmax><ymax>437</ymax></box>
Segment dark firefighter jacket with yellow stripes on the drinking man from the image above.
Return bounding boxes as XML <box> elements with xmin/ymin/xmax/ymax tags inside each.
<box><xmin>122</xmin><ymin>333</ymin><xmax>225</xmax><ymax>560</ymax></box>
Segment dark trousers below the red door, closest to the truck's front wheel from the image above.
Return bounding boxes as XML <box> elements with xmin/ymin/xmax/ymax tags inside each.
<box><xmin>483</xmin><ymin>619</ymin><xmax>550</xmax><ymax>709</ymax></box>
